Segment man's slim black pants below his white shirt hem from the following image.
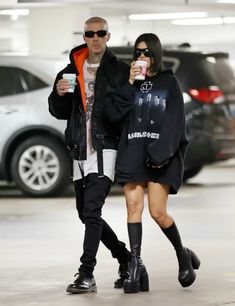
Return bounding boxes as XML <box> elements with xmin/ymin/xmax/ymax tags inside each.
<box><xmin>74</xmin><ymin>173</ymin><xmax>126</xmax><ymax>275</ymax></box>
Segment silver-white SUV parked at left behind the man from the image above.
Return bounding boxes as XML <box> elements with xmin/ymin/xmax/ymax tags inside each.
<box><xmin>0</xmin><ymin>55</ymin><xmax>71</xmax><ymax>196</ymax></box>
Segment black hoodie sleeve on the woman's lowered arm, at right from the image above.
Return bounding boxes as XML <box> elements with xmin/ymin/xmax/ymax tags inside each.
<box><xmin>147</xmin><ymin>77</ymin><xmax>185</xmax><ymax>166</ymax></box>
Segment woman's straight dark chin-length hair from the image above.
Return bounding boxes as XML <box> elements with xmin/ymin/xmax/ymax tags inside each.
<box><xmin>133</xmin><ymin>33</ymin><xmax>162</xmax><ymax>73</ymax></box>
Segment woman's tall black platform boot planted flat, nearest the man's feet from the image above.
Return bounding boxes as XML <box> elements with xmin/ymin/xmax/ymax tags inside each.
<box><xmin>124</xmin><ymin>223</ymin><xmax>149</xmax><ymax>293</ymax></box>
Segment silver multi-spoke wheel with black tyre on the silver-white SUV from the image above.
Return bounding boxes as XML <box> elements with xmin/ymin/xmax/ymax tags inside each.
<box><xmin>11</xmin><ymin>136</ymin><xmax>71</xmax><ymax>197</ymax></box>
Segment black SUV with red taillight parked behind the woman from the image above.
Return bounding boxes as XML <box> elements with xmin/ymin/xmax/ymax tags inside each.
<box><xmin>111</xmin><ymin>44</ymin><xmax>235</xmax><ymax>180</ymax></box>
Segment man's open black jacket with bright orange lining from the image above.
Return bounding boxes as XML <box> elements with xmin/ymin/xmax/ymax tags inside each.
<box><xmin>48</xmin><ymin>44</ymin><xmax>129</xmax><ymax>160</ymax></box>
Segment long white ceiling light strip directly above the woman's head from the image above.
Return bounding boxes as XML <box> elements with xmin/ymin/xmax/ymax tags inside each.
<box><xmin>129</xmin><ymin>12</ymin><xmax>208</xmax><ymax>20</ymax></box>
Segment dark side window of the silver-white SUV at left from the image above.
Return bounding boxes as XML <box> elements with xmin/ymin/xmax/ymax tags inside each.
<box><xmin>0</xmin><ymin>66</ymin><xmax>48</xmax><ymax>97</ymax></box>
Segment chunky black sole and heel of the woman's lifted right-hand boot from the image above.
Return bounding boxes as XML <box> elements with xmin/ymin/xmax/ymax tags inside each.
<box><xmin>178</xmin><ymin>249</ymin><xmax>201</xmax><ymax>288</ymax></box>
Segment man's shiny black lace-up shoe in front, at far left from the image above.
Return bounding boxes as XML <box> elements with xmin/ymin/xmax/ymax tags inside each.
<box><xmin>66</xmin><ymin>272</ymin><xmax>97</xmax><ymax>294</ymax></box>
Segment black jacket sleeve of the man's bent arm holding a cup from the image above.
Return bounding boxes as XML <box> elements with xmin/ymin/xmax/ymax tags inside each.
<box><xmin>48</xmin><ymin>64</ymin><xmax>74</xmax><ymax>120</ymax></box>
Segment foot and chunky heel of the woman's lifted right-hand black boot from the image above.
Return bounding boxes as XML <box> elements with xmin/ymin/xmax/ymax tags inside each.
<box><xmin>176</xmin><ymin>247</ymin><xmax>201</xmax><ymax>287</ymax></box>
